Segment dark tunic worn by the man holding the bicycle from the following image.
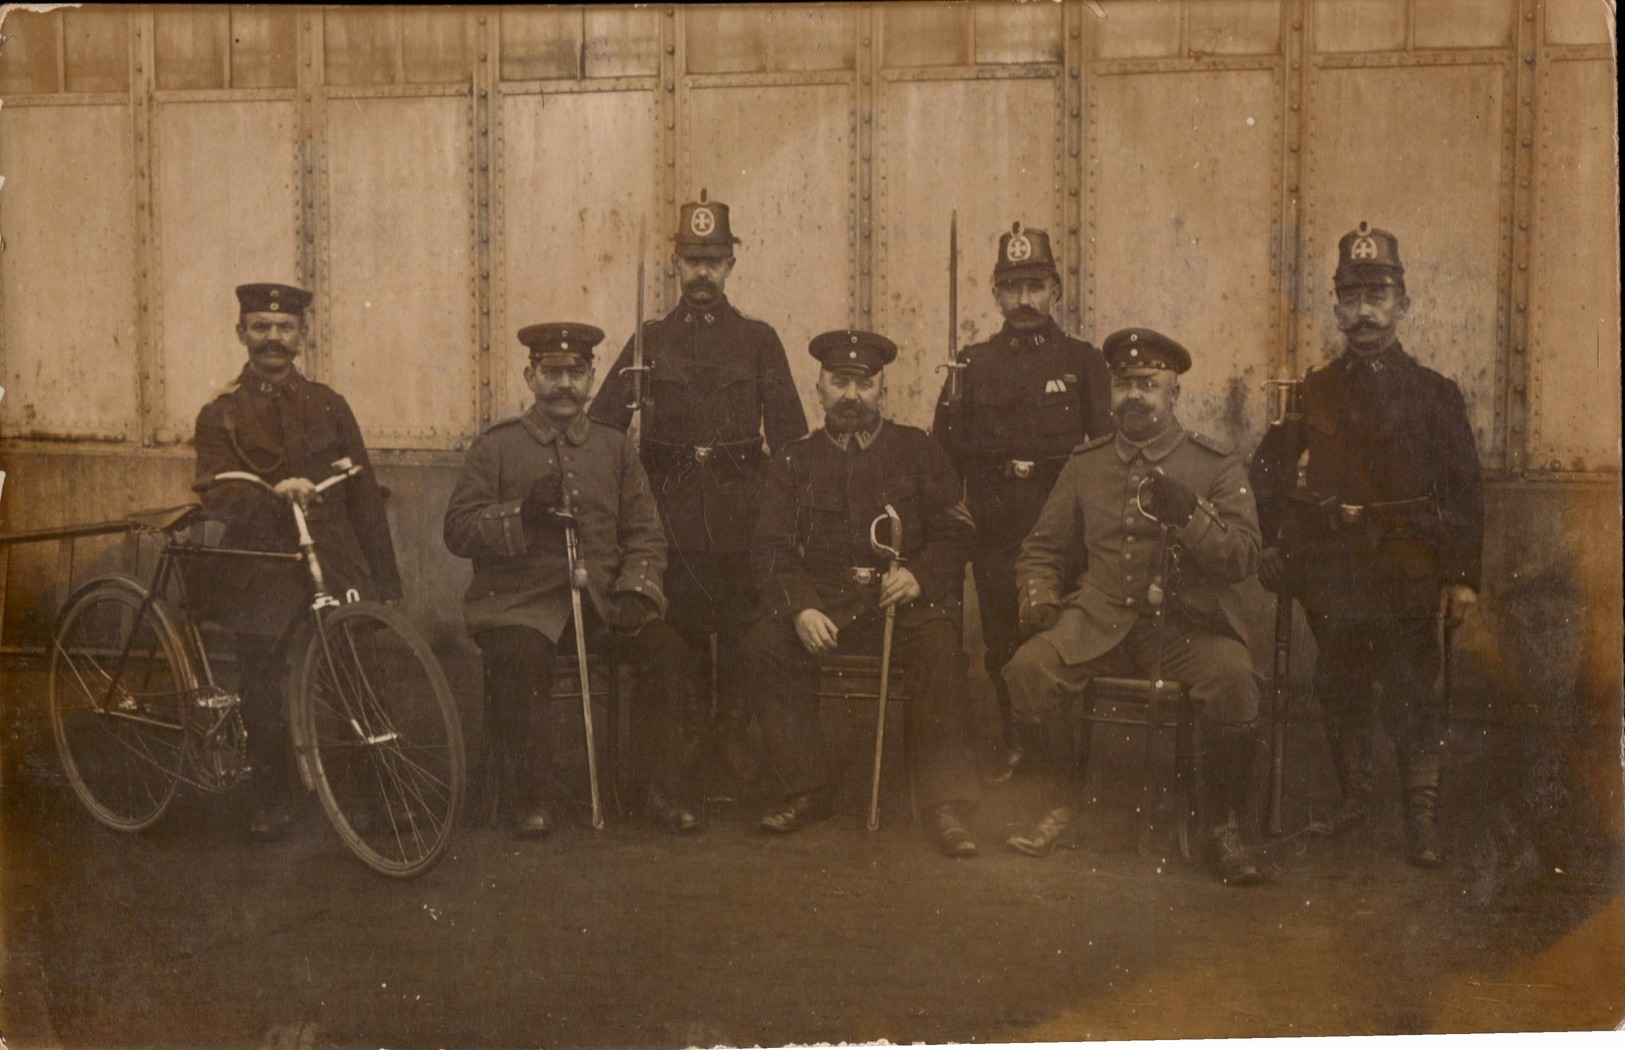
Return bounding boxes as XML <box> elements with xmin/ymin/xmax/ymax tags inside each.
<box><xmin>192</xmin><ymin>367</ymin><xmax>401</xmax><ymax>636</ymax></box>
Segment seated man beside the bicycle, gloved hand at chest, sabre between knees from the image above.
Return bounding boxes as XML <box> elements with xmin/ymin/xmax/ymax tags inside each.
<box><xmin>445</xmin><ymin>323</ymin><xmax>704</xmax><ymax>837</ymax></box>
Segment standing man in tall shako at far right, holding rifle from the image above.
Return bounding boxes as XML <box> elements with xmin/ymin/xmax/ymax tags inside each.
<box><xmin>1251</xmin><ymin>223</ymin><xmax>1484</xmax><ymax>868</ymax></box>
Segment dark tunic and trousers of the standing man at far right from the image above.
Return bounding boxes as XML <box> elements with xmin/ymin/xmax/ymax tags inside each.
<box><xmin>1251</xmin><ymin>343</ymin><xmax>1484</xmax><ymax>751</ymax></box>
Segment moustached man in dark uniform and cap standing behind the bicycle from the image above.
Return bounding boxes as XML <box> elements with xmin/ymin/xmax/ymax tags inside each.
<box><xmin>193</xmin><ymin>284</ymin><xmax>401</xmax><ymax>839</ymax></box>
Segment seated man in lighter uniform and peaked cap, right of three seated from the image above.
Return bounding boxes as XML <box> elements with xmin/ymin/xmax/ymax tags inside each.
<box><xmin>1004</xmin><ymin>328</ymin><xmax>1259</xmax><ymax>886</ymax></box>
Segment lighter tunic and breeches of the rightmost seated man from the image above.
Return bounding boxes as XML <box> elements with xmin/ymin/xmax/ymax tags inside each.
<box><xmin>1004</xmin><ymin>421</ymin><xmax>1259</xmax><ymax>723</ymax></box>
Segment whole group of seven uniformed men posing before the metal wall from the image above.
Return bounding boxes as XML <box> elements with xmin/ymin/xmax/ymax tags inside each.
<box><xmin>197</xmin><ymin>199</ymin><xmax>1484</xmax><ymax>884</ymax></box>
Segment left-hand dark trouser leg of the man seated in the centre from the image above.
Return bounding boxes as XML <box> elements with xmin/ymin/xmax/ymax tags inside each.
<box><xmin>739</xmin><ymin>616</ymin><xmax>829</xmax><ymax>796</ymax></box>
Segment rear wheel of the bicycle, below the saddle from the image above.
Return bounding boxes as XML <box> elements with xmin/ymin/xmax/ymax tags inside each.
<box><xmin>50</xmin><ymin>577</ymin><xmax>195</xmax><ymax>831</ymax></box>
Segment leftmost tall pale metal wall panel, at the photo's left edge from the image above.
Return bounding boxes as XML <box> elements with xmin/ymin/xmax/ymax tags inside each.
<box><xmin>0</xmin><ymin>106</ymin><xmax>140</xmax><ymax>439</ymax></box>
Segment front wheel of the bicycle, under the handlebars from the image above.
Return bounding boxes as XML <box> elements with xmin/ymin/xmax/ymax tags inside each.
<box><xmin>294</xmin><ymin>601</ymin><xmax>466</xmax><ymax>878</ymax></box>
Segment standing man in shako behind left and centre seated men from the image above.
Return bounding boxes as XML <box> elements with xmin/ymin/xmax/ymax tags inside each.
<box><xmin>590</xmin><ymin>190</ymin><xmax>808</xmax><ymax>783</ymax></box>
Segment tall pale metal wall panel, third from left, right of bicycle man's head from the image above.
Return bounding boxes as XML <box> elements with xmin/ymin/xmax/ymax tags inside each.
<box><xmin>320</xmin><ymin>98</ymin><xmax>478</xmax><ymax>449</ymax></box>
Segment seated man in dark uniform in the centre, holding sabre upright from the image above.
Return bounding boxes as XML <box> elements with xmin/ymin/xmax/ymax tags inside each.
<box><xmin>744</xmin><ymin>332</ymin><xmax>977</xmax><ymax>857</ymax></box>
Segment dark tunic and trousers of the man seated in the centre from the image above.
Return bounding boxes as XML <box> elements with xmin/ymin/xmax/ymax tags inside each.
<box><xmin>743</xmin><ymin>421</ymin><xmax>975</xmax><ymax>806</ymax></box>
